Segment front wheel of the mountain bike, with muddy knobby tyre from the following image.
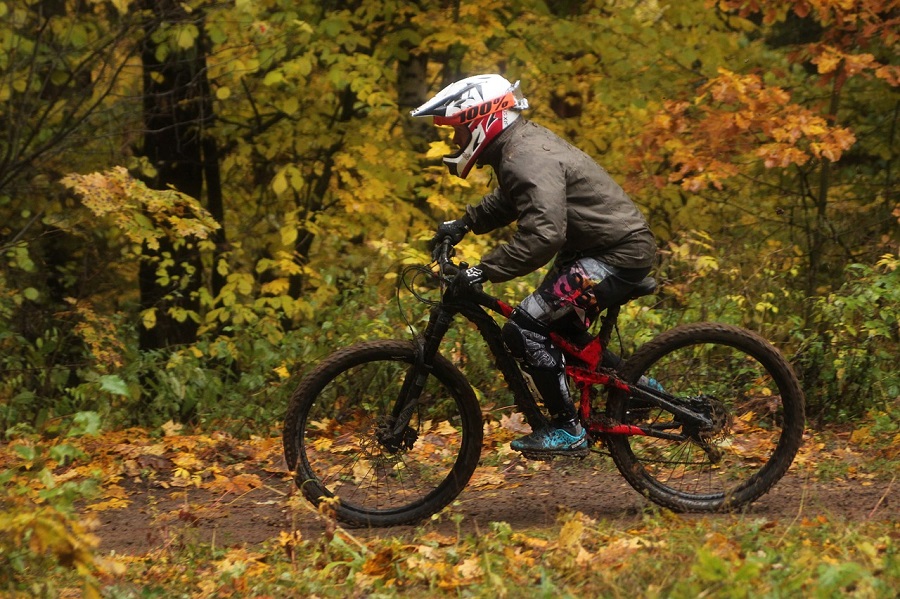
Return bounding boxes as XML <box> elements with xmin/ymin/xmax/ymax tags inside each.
<box><xmin>282</xmin><ymin>340</ymin><xmax>482</xmax><ymax>526</ymax></box>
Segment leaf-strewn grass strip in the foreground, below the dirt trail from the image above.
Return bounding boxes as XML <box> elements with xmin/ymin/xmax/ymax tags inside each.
<box><xmin>75</xmin><ymin>510</ymin><xmax>900</xmax><ymax>598</ymax></box>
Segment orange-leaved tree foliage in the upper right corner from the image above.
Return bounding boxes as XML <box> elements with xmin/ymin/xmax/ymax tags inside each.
<box><xmin>633</xmin><ymin>0</ymin><xmax>900</xmax><ymax>295</ymax></box>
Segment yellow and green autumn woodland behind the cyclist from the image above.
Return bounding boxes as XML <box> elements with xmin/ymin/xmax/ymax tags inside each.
<box><xmin>0</xmin><ymin>0</ymin><xmax>900</xmax><ymax>593</ymax></box>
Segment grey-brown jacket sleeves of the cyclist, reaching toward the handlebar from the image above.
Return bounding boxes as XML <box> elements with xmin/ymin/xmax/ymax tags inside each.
<box><xmin>472</xmin><ymin>151</ymin><xmax>566</xmax><ymax>283</ymax></box>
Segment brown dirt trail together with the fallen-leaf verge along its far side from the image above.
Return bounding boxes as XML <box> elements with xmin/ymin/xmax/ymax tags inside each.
<box><xmin>87</xmin><ymin>433</ymin><xmax>900</xmax><ymax>555</ymax></box>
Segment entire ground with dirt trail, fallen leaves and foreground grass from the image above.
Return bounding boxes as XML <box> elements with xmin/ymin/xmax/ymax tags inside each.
<box><xmin>8</xmin><ymin>414</ymin><xmax>900</xmax><ymax>599</ymax></box>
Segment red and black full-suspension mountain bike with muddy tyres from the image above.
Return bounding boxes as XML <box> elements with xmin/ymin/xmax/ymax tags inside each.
<box><xmin>283</xmin><ymin>244</ymin><xmax>804</xmax><ymax>526</ymax></box>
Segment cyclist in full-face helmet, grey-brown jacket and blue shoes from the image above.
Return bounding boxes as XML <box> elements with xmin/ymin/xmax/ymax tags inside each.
<box><xmin>411</xmin><ymin>75</ymin><xmax>656</xmax><ymax>454</ymax></box>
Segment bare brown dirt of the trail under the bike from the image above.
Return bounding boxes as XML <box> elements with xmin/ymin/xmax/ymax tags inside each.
<box><xmin>95</xmin><ymin>460</ymin><xmax>900</xmax><ymax>554</ymax></box>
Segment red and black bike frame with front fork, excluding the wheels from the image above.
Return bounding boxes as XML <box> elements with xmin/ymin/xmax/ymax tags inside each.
<box><xmin>391</xmin><ymin>262</ymin><xmax>712</xmax><ymax>440</ymax></box>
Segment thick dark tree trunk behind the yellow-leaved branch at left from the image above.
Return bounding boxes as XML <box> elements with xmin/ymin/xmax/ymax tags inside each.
<box><xmin>140</xmin><ymin>0</ymin><xmax>224</xmax><ymax>350</ymax></box>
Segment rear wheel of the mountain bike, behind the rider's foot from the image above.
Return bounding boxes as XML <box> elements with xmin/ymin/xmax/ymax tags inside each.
<box><xmin>606</xmin><ymin>323</ymin><xmax>805</xmax><ymax>511</ymax></box>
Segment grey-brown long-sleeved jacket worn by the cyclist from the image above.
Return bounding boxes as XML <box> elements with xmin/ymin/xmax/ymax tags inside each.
<box><xmin>464</xmin><ymin>118</ymin><xmax>656</xmax><ymax>283</ymax></box>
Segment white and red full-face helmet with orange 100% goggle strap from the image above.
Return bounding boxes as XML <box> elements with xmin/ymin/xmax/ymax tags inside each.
<box><xmin>410</xmin><ymin>75</ymin><xmax>528</xmax><ymax>179</ymax></box>
